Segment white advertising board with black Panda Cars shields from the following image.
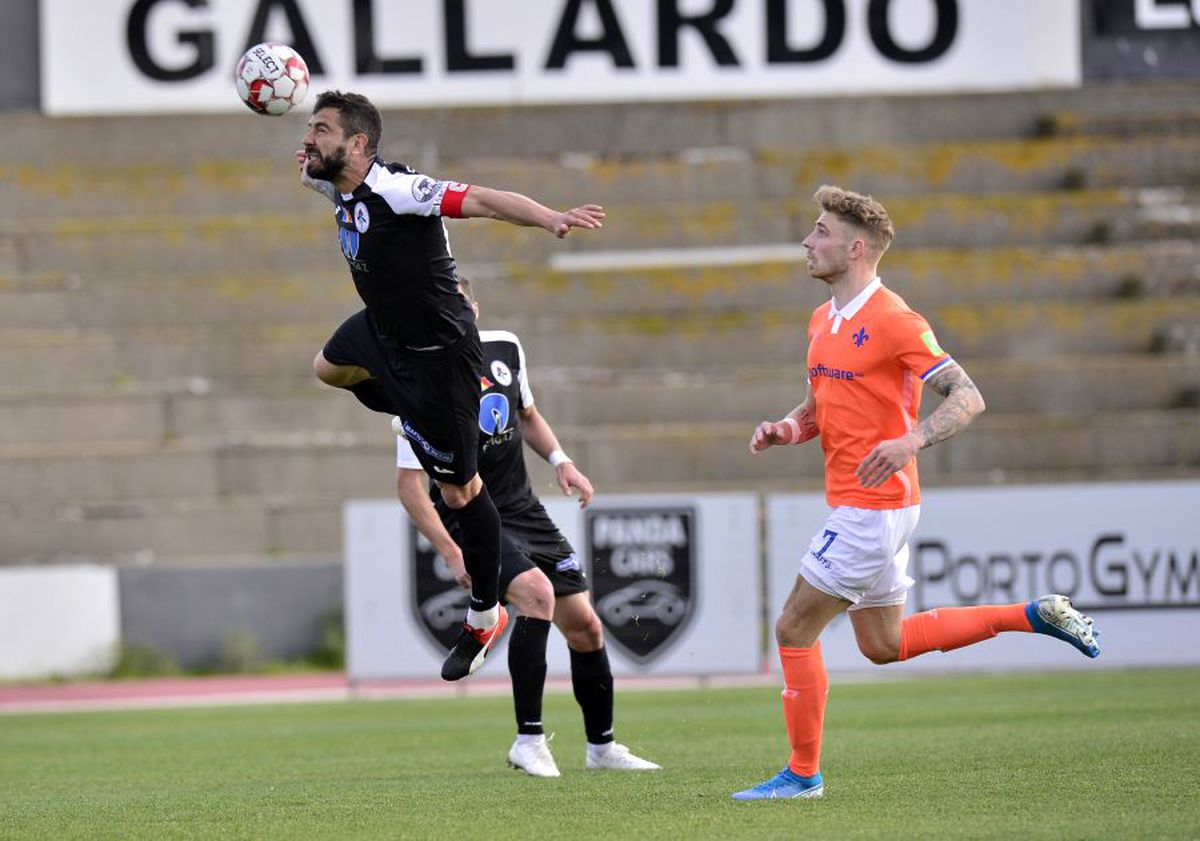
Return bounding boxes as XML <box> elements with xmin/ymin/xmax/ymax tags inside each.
<box><xmin>343</xmin><ymin>494</ymin><xmax>762</xmax><ymax>680</ymax></box>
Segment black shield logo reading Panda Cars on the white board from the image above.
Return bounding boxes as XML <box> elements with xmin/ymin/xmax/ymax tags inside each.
<box><xmin>584</xmin><ymin>507</ymin><xmax>696</xmax><ymax>663</ymax></box>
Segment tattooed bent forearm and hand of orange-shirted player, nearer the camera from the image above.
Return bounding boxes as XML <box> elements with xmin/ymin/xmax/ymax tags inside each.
<box><xmin>856</xmin><ymin>364</ymin><xmax>985</xmax><ymax>487</ymax></box>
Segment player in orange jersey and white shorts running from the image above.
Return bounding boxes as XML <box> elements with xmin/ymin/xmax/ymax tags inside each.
<box><xmin>733</xmin><ymin>186</ymin><xmax>1100</xmax><ymax>800</ymax></box>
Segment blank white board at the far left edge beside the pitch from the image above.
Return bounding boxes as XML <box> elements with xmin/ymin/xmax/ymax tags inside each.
<box><xmin>0</xmin><ymin>565</ymin><xmax>121</xmax><ymax>680</ymax></box>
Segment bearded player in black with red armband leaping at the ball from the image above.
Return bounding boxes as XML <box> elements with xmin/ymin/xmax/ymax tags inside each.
<box><xmin>298</xmin><ymin>91</ymin><xmax>604</xmax><ymax>680</ymax></box>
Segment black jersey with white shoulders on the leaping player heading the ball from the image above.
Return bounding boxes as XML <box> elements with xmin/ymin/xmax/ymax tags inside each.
<box><xmin>334</xmin><ymin>158</ymin><xmax>475</xmax><ymax>353</ymax></box>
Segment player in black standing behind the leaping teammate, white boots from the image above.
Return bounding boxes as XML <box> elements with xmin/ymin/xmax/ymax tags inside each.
<box><xmin>392</xmin><ymin>278</ymin><xmax>659</xmax><ymax>776</ymax></box>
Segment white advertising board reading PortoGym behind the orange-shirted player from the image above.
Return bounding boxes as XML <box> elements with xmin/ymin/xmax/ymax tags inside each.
<box><xmin>767</xmin><ymin>482</ymin><xmax>1200</xmax><ymax>671</ymax></box>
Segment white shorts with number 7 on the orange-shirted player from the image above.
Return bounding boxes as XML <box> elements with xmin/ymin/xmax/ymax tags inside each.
<box><xmin>800</xmin><ymin>505</ymin><xmax>920</xmax><ymax>611</ymax></box>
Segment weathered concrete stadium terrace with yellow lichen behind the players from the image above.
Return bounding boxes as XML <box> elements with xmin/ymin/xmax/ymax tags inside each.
<box><xmin>0</xmin><ymin>83</ymin><xmax>1200</xmax><ymax>565</ymax></box>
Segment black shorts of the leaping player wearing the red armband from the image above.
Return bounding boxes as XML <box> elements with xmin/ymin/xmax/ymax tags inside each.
<box><xmin>322</xmin><ymin>310</ymin><xmax>484</xmax><ymax>485</ymax></box>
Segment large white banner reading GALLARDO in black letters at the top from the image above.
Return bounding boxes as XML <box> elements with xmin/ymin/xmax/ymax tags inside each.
<box><xmin>40</xmin><ymin>0</ymin><xmax>1081</xmax><ymax>114</ymax></box>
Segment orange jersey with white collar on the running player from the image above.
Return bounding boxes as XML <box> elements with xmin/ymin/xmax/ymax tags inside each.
<box><xmin>808</xmin><ymin>278</ymin><xmax>954</xmax><ymax>509</ymax></box>
